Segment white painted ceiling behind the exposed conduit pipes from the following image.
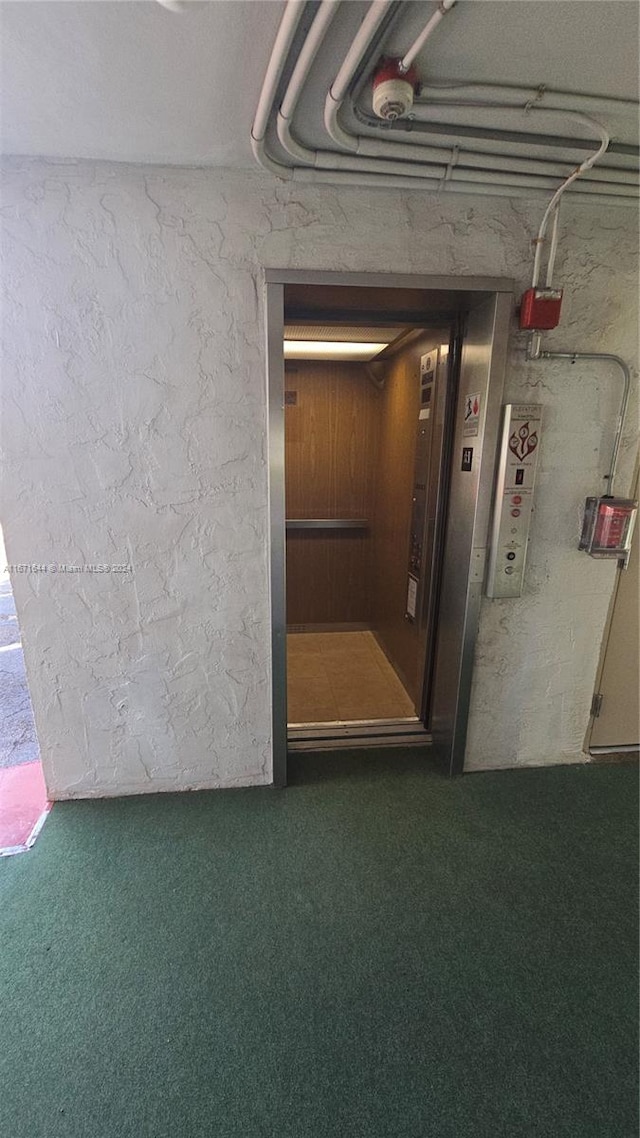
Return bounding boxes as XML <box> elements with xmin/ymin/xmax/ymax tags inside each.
<box><xmin>0</xmin><ymin>0</ymin><xmax>639</xmax><ymax>167</ymax></box>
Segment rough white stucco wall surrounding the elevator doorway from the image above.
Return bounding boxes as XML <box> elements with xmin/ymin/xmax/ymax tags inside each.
<box><xmin>1</xmin><ymin>159</ymin><xmax>638</xmax><ymax>798</ymax></box>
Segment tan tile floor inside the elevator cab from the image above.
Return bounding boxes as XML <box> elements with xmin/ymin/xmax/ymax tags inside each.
<box><xmin>287</xmin><ymin>632</ymin><xmax>416</xmax><ymax>724</ymax></box>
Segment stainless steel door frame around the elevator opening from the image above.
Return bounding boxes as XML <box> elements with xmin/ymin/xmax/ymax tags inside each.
<box><xmin>265</xmin><ymin>269</ymin><xmax>514</xmax><ymax>786</ymax></box>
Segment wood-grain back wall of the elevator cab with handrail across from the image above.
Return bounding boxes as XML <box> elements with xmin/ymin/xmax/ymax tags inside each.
<box><xmin>285</xmin><ymin>362</ymin><xmax>381</xmax><ymax>627</ymax></box>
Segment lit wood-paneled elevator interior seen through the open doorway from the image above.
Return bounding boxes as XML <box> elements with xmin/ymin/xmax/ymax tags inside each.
<box><xmin>285</xmin><ymin>279</ymin><xmax>460</xmax><ymax>732</ymax></box>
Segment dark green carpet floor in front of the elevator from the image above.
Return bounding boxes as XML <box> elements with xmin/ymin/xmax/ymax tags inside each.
<box><xmin>0</xmin><ymin>751</ymin><xmax>638</xmax><ymax>1138</ymax></box>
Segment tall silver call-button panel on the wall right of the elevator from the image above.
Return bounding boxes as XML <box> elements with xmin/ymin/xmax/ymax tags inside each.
<box><xmin>486</xmin><ymin>403</ymin><xmax>542</xmax><ymax>597</ymax></box>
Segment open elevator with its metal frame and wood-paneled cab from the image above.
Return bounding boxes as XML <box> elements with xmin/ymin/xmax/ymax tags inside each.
<box><xmin>268</xmin><ymin>271</ymin><xmax>512</xmax><ymax>784</ymax></box>
